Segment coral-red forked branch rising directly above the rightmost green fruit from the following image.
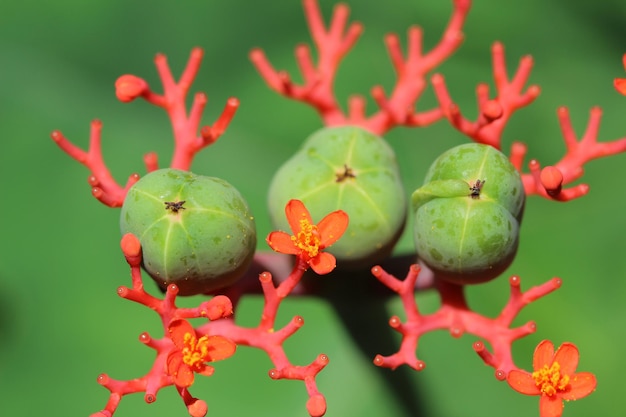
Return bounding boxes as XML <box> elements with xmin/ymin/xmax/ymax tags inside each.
<box><xmin>431</xmin><ymin>42</ymin><xmax>540</xmax><ymax>149</ymax></box>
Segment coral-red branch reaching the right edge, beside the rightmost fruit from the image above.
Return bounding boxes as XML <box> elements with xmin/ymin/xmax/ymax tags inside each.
<box><xmin>511</xmin><ymin>107</ymin><xmax>626</xmax><ymax>201</ymax></box>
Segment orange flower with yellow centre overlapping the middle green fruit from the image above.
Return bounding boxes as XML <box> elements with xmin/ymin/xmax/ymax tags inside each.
<box><xmin>266</xmin><ymin>200</ymin><xmax>348</xmax><ymax>275</ymax></box>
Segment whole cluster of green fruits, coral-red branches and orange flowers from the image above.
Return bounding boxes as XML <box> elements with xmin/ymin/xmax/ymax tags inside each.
<box><xmin>52</xmin><ymin>0</ymin><xmax>626</xmax><ymax>417</ymax></box>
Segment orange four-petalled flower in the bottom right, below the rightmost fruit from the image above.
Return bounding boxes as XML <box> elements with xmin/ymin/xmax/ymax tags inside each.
<box><xmin>507</xmin><ymin>340</ymin><xmax>597</xmax><ymax>417</ymax></box>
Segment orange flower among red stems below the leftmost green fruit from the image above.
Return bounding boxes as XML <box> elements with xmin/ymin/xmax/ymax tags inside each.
<box><xmin>167</xmin><ymin>319</ymin><xmax>237</xmax><ymax>387</ymax></box>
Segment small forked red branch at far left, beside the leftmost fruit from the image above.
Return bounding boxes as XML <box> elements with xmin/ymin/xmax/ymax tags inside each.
<box><xmin>50</xmin><ymin>120</ymin><xmax>139</xmax><ymax>207</ymax></box>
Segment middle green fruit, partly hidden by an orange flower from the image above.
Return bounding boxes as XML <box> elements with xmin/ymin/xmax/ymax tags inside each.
<box><xmin>269</xmin><ymin>126</ymin><xmax>407</xmax><ymax>267</ymax></box>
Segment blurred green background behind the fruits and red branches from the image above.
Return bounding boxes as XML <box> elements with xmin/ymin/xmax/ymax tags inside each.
<box><xmin>0</xmin><ymin>0</ymin><xmax>626</xmax><ymax>417</ymax></box>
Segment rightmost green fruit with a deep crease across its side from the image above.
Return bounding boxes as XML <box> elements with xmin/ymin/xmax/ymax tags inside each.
<box><xmin>412</xmin><ymin>143</ymin><xmax>526</xmax><ymax>284</ymax></box>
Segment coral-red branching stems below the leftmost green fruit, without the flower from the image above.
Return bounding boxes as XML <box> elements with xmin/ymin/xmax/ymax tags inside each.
<box><xmin>92</xmin><ymin>234</ymin><xmax>329</xmax><ymax>417</ymax></box>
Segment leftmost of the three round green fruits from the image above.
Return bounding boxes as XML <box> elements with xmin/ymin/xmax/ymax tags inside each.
<box><xmin>120</xmin><ymin>169</ymin><xmax>256</xmax><ymax>295</ymax></box>
